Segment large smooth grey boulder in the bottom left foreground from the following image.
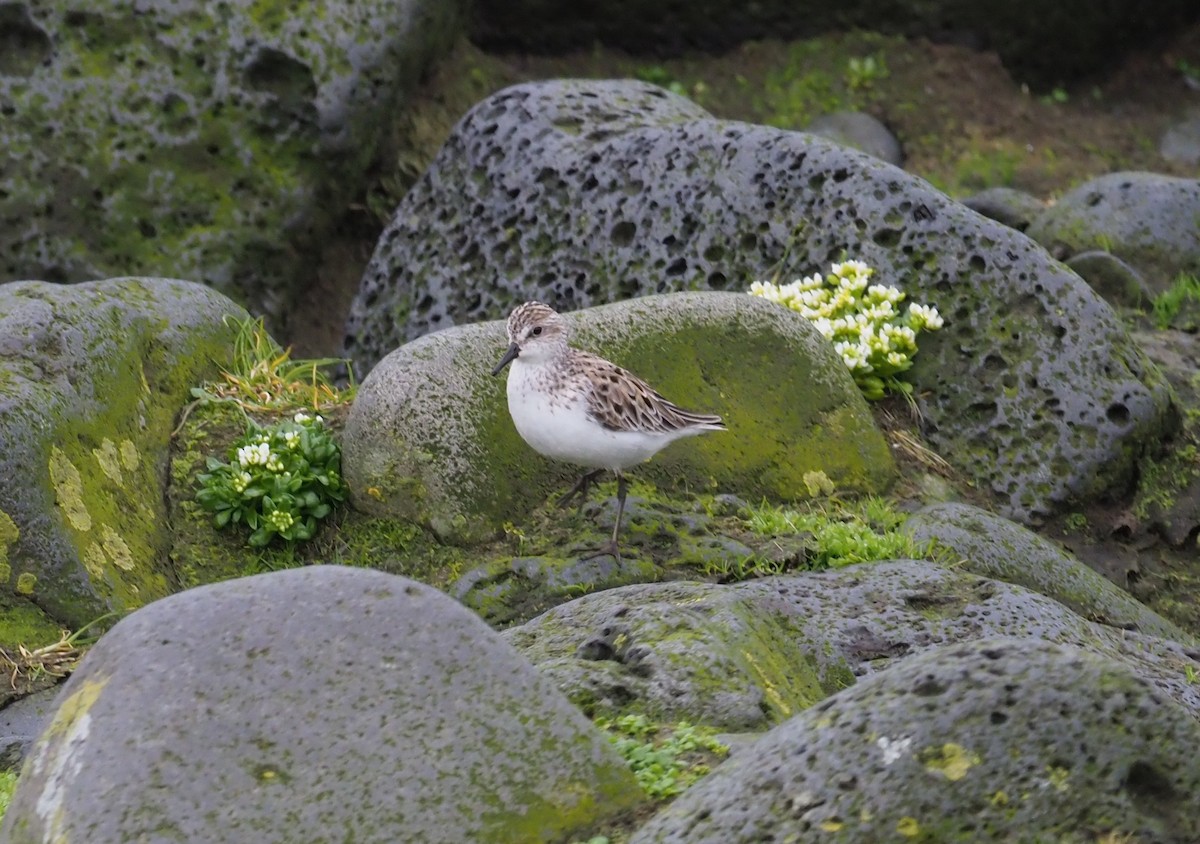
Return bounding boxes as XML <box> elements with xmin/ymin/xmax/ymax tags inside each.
<box><xmin>0</xmin><ymin>565</ymin><xmax>642</xmax><ymax>844</ymax></box>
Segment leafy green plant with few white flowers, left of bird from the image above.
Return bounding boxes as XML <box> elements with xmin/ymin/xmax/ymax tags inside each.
<box><xmin>196</xmin><ymin>413</ymin><xmax>346</xmax><ymax>547</ymax></box>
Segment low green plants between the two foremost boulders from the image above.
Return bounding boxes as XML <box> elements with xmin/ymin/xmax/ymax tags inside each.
<box><xmin>593</xmin><ymin>714</ymin><xmax>730</xmax><ymax>797</ymax></box>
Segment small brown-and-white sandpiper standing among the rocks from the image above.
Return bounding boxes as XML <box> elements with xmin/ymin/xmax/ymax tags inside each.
<box><xmin>492</xmin><ymin>301</ymin><xmax>728</xmax><ymax>562</ymax></box>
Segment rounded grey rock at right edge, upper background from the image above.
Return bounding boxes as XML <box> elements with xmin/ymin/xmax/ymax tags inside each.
<box><xmin>1028</xmin><ymin>173</ymin><xmax>1200</xmax><ymax>294</ymax></box>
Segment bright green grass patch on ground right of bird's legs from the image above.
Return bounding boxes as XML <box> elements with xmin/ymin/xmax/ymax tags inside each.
<box><xmin>746</xmin><ymin>496</ymin><xmax>932</xmax><ymax>570</ymax></box>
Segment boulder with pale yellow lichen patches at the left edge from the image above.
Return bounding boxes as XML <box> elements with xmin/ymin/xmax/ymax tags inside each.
<box><xmin>0</xmin><ymin>279</ymin><xmax>246</xmax><ymax>647</ymax></box>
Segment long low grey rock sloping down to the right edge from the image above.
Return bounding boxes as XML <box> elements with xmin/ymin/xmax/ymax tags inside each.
<box><xmin>905</xmin><ymin>503</ymin><xmax>1193</xmax><ymax>644</ymax></box>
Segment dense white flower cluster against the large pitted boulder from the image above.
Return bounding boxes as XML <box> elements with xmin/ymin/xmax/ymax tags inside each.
<box><xmin>750</xmin><ymin>261</ymin><xmax>943</xmax><ymax>400</ymax></box>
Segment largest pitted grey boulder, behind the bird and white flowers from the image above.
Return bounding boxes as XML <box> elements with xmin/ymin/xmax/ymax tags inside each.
<box><xmin>347</xmin><ymin>80</ymin><xmax>1169</xmax><ymax>521</ymax></box>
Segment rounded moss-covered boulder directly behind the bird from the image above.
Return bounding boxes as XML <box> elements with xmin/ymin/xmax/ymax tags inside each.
<box><xmin>342</xmin><ymin>293</ymin><xmax>895</xmax><ymax>541</ymax></box>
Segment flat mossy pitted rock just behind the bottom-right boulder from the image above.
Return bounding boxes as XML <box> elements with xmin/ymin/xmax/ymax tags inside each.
<box><xmin>504</xmin><ymin>559</ymin><xmax>1200</xmax><ymax>730</ymax></box>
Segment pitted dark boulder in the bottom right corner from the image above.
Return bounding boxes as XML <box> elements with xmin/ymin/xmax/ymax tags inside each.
<box><xmin>631</xmin><ymin>639</ymin><xmax>1200</xmax><ymax>844</ymax></box>
